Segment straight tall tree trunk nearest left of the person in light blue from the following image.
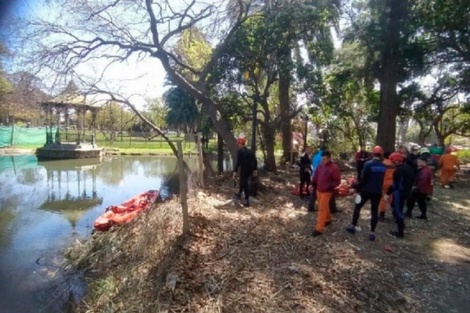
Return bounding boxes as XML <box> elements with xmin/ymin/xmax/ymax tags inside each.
<box><xmin>278</xmin><ymin>47</ymin><xmax>292</xmax><ymax>162</ymax></box>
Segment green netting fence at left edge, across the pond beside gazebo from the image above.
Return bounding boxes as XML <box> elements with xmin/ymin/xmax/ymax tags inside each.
<box><xmin>0</xmin><ymin>126</ymin><xmax>56</xmax><ymax>148</ymax></box>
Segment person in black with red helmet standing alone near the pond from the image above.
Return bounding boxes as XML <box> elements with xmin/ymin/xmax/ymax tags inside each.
<box><xmin>233</xmin><ymin>137</ymin><xmax>258</xmax><ymax>207</ymax></box>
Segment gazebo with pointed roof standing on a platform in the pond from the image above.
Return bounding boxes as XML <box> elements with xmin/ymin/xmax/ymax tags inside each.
<box><xmin>36</xmin><ymin>81</ymin><xmax>103</xmax><ymax>159</ymax></box>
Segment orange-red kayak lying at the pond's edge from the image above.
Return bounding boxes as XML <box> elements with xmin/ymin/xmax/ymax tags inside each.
<box><xmin>93</xmin><ymin>190</ymin><xmax>159</xmax><ymax>231</ymax></box>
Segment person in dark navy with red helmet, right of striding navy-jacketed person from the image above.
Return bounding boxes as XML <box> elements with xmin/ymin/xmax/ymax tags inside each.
<box><xmin>384</xmin><ymin>152</ymin><xmax>414</xmax><ymax>238</ymax></box>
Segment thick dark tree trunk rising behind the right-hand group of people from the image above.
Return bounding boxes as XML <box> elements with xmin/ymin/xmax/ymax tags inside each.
<box><xmin>377</xmin><ymin>0</ymin><xmax>408</xmax><ymax>151</ymax></box>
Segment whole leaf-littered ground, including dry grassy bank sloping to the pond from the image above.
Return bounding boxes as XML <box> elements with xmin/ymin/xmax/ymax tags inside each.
<box><xmin>71</xmin><ymin>165</ymin><xmax>470</xmax><ymax>313</ymax></box>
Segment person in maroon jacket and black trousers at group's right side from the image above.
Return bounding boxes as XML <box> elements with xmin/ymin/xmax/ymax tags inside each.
<box><xmin>406</xmin><ymin>157</ymin><xmax>433</xmax><ymax>220</ymax></box>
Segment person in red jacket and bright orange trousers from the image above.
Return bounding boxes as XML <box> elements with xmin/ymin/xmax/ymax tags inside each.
<box><xmin>312</xmin><ymin>151</ymin><xmax>341</xmax><ymax>236</ymax></box>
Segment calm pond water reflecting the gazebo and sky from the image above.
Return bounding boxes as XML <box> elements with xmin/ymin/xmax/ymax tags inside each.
<box><xmin>0</xmin><ymin>155</ymin><xmax>222</xmax><ymax>313</ymax></box>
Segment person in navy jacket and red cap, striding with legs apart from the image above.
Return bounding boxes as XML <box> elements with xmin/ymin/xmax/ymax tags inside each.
<box><xmin>346</xmin><ymin>146</ymin><xmax>387</xmax><ymax>241</ymax></box>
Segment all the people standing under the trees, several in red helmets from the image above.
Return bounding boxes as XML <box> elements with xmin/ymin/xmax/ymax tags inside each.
<box><xmin>233</xmin><ymin>138</ymin><xmax>460</xmax><ymax>241</ymax></box>
